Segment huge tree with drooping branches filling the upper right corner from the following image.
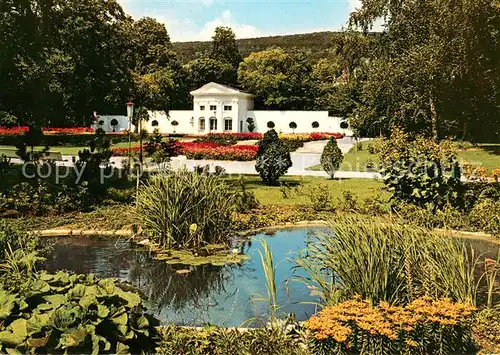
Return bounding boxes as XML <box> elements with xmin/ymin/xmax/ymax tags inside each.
<box><xmin>351</xmin><ymin>0</ymin><xmax>500</xmax><ymax>139</ymax></box>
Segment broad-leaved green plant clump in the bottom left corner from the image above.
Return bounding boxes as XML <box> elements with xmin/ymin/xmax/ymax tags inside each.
<box><xmin>0</xmin><ymin>272</ymin><xmax>158</xmax><ymax>354</ymax></box>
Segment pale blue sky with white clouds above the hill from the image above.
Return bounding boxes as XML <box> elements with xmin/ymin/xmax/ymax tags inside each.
<box><xmin>118</xmin><ymin>0</ymin><xmax>374</xmax><ymax>42</ymax></box>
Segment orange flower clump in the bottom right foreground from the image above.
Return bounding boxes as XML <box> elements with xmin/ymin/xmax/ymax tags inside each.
<box><xmin>306</xmin><ymin>298</ymin><xmax>475</xmax><ymax>355</ymax></box>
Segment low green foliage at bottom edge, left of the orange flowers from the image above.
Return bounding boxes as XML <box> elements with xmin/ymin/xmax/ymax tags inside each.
<box><xmin>156</xmin><ymin>326</ymin><xmax>309</xmax><ymax>355</ymax></box>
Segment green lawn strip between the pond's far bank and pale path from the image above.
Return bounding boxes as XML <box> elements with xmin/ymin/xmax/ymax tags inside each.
<box><xmin>224</xmin><ymin>176</ymin><xmax>388</xmax><ymax>205</ymax></box>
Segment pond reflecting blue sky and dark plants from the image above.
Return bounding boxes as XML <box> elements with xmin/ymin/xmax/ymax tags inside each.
<box><xmin>43</xmin><ymin>227</ymin><xmax>500</xmax><ymax>326</ymax></box>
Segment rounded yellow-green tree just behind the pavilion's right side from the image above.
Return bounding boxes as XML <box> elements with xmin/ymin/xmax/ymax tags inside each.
<box><xmin>238</xmin><ymin>48</ymin><xmax>314</xmax><ymax>110</ymax></box>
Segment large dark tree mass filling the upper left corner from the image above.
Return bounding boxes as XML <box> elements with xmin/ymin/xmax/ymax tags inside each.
<box><xmin>0</xmin><ymin>0</ymin><xmax>131</xmax><ymax>126</ymax></box>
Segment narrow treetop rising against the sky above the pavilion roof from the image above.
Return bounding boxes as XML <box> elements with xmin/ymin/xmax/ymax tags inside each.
<box><xmin>211</xmin><ymin>26</ymin><xmax>243</xmax><ymax>70</ymax></box>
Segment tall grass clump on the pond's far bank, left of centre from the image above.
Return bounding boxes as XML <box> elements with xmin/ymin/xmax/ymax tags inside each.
<box><xmin>133</xmin><ymin>171</ymin><xmax>234</xmax><ymax>249</ymax></box>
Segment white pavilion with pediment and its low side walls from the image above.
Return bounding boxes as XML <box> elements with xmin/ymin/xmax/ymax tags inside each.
<box><xmin>95</xmin><ymin>83</ymin><xmax>351</xmax><ymax>135</ymax></box>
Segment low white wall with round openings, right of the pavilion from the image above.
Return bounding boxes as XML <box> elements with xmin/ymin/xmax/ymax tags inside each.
<box><xmin>244</xmin><ymin>110</ymin><xmax>351</xmax><ymax>135</ymax></box>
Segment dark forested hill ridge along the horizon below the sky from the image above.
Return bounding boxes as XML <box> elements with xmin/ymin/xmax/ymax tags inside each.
<box><xmin>173</xmin><ymin>32</ymin><xmax>334</xmax><ymax>63</ymax></box>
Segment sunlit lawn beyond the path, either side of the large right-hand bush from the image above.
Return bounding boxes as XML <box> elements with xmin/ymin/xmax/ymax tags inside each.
<box><xmin>309</xmin><ymin>142</ymin><xmax>500</xmax><ymax>172</ymax></box>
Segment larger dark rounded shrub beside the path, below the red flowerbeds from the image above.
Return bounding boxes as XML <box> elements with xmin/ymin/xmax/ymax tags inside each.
<box><xmin>255</xmin><ymin>134</ymin><xmax>292</xmax><ymax>185</ymax></box>
